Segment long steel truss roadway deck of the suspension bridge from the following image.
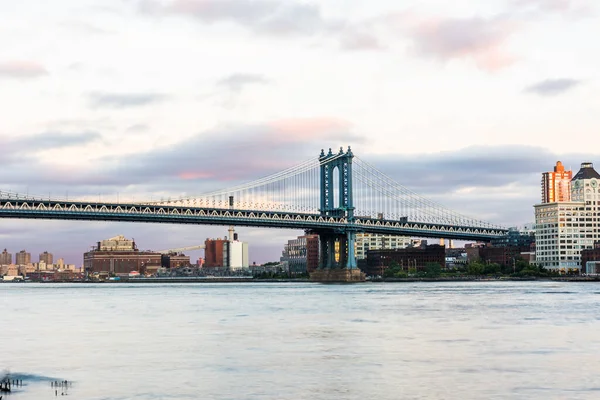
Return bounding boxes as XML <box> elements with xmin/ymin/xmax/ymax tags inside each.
<box><xmin>0</xmin><ymin>196</ymin><xmax>507</xmax><ymax>241</ymax></box>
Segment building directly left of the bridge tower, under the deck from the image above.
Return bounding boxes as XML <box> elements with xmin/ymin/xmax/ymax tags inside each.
<box><xmin>280</xmin><ymin>235</ymin><xmax>319</xmax><ymax>275</ymax></box>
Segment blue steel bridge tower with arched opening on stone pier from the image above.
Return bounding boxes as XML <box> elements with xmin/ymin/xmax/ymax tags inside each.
<box><xmin>314</xmin><ymin>147</ymin><xmax>362</xmax><ymax>282</ymax></box>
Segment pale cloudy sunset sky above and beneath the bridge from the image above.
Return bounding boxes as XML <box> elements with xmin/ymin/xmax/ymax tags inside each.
<box><xmin>0</xmin><ymin>0</ymin><xmax>600</xmax><ymax>265</ymax></box>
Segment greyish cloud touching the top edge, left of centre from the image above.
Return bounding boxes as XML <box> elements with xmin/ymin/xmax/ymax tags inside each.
<box><xmin>145</xmin><ymin>0</ymin><xmax>330</xmax><ymax>35</ymax></box>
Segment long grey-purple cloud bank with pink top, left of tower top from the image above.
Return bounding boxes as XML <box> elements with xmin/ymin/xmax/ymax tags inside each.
<box><xmin>0</xmin><ymin>117</ymin><xmax>356</xmax><ymax>194</ymax></box>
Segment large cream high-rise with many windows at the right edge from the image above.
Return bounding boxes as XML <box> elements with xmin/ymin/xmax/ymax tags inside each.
<box><xmin>534</xmin><ymin>162</ymin><xmax>600</xmax><ymax>272</ymax></box>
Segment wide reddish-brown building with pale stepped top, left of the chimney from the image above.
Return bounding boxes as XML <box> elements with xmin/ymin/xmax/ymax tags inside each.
<box><xmin>83</xmin><ymin>236</ymin><xmax>161</xmax><ymax>277</ymax></box>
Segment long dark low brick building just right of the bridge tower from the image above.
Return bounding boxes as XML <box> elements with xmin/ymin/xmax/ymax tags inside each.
<box><xmin>360</xmin><ymin>244</ymin><xmax>446</xmax><ymax>276</ymax></box>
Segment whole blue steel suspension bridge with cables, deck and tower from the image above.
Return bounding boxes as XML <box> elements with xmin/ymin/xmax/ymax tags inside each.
<box><xmin>0</xmin><ymin>148</ymin><xmax>507</xmax><ymax>282</ymax></box>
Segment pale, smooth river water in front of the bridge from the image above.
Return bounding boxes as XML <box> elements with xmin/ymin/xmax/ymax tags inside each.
<box><xmin>0</xmin><ymin>282</ymin><xmax>600</xmax><ymax>400</ymax></box>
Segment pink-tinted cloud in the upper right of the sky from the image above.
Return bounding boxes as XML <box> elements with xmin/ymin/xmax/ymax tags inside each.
<box><xmin>393</xmin><ymin>14</ymin><xmax>516</xmax><ymax>71</ymax></box>
